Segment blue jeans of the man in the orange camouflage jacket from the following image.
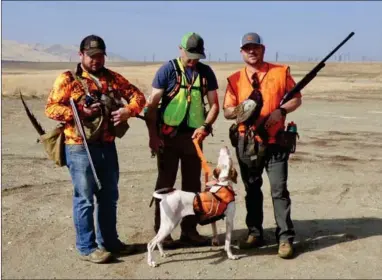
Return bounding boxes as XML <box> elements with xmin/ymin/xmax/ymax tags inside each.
<box><xmin>65</xmin><ymin>142</ymin><xmax>121</xmax><ymax>255</ymax></box>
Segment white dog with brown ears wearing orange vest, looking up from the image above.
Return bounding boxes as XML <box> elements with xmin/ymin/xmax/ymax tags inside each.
<box><xmin>147</xmin><ymin>147</ymin><xmax>239</xmax><ymax>267</ymax></box>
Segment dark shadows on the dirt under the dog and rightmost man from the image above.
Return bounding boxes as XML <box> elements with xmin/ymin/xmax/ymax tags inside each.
<box><xmin>143</xmin><ymin>217</ymin><xmax>382</xmax><ymax>264</ymax></box>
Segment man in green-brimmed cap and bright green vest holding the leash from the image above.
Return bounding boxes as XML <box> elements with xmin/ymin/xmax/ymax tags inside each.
<box><xmin>146</xmin><ymin>32</ymin><xmax>219</xmax><ymax>246</ymax></box>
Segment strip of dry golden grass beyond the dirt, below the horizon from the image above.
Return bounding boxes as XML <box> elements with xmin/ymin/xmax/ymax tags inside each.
<box><xmin>2</xmin><ymin>62</ymin><xmax>382</xmax><ymax>100</ymax></box>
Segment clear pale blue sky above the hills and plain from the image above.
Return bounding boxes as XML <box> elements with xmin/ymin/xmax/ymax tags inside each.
<box><xmin>2</xmin><ymin>1</ymin><xmax>382</xmax><ymax>60</ymax></box>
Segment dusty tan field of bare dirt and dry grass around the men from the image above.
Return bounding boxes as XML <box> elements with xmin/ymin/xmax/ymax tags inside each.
<box><xmin>1</xmin><ymin>63</ymin><xmax>382</xmax><ymax>279</ymax></box>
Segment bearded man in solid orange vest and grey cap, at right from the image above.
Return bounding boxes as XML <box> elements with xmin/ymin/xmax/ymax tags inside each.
<box><xmin>223</xmin><ymin>32</ymin><xmax>301</xmax><ymax>258</ymax></box>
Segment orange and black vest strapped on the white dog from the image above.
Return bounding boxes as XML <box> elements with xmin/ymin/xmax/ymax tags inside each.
<box><xmin>193</xmin><ymin>185</ymin><xmax>235</xmax><ymax>225</ymax></box>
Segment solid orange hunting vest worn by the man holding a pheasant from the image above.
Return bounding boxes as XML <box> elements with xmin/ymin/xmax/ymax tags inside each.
<box><xmin>228</xmin><ymin>63</ymin><xmax>289</xmax><ymax>144</ymax></box>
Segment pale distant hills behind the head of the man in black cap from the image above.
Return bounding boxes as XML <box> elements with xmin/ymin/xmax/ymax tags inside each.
<box><xmin>1</xmin><ymin>40</ymin><xmax>127</xmax><ymax>62</ymax></box>
